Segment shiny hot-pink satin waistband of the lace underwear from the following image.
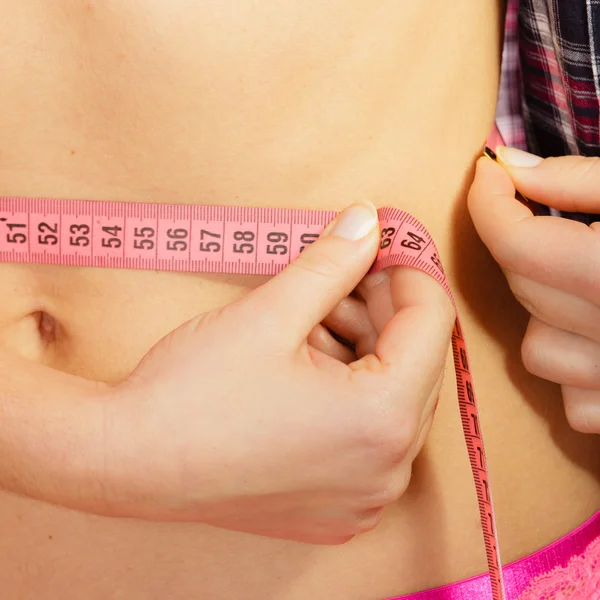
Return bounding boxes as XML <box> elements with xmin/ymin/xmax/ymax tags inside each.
<box><xmin>389</xmin><ymin>512</ymin><xmax>600</xmax><ymax>600</ymax></box>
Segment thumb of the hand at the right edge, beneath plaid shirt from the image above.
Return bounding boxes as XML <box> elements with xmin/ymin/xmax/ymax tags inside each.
<box><xmin>496</xmin><ymin>146</ymin><xmax>600</xmax><ymax>213</ymax></box>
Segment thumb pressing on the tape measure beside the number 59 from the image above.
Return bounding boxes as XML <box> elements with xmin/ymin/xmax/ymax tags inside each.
<box><xmin>242</xmin><ymin>203</ymin><xmax>379</xmax><ymax>343</ymax></box>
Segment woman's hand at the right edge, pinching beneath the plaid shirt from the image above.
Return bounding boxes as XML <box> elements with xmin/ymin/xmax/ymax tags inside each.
<box><xmin>469</xmin><ymin>147</ymin><xmax>600</xmax><ymax>433</ymax></box>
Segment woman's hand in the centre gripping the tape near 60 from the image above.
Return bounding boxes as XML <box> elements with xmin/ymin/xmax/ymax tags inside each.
<box><xmin>102</xmin><ymin>205</ymin><xmax>455</xmax><ymax>544</ymax></box>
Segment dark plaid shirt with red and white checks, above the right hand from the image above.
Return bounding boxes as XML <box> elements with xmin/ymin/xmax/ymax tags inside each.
<box><xmin>496</xmin><ymin>0</ymin><xmax>600</xmax><ymax>223</ymax></box>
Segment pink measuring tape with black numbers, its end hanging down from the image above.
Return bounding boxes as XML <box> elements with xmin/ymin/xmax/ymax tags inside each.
<box><xmin>0</xmin><ymin>197</ymin><xmax>505</xmax><ymax>600</ymax></box>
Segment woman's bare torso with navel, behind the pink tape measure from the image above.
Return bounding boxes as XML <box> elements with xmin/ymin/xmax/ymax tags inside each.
<box><xmin>0</xmin><ymin>0</ymin><xmax>600</xmax><ymax>600</ymax></box>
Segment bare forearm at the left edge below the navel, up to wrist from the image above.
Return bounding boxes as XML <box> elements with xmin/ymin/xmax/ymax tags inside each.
<box><xmin>0</xmin><ymin>353</ymin><xmax>107</xmax><ymax>513</ymax></box>
